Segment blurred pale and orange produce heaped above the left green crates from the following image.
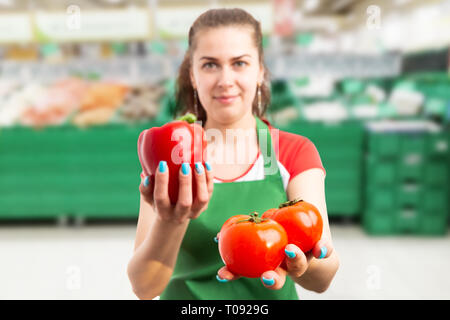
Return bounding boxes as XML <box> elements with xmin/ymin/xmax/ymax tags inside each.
<box><xmin>0</xmin><ymin>77</ymin><xmax>166</xmax><ymax>128</ymax></box>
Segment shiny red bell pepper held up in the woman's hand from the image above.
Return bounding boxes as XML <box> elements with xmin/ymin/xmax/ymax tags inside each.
<box><xmin>138</xmin><ymin>114</ymin><xmax>207</xmax><ymax>204</ymax></box>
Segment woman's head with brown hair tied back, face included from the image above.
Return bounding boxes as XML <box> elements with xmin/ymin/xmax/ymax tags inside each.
<box><xmin>177</xmin><ymin>9</ymin><xmax>270</xmax><ymax>125</ymax></box>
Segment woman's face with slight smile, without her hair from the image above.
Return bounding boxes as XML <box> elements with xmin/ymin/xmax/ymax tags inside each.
<box><xmin>190</xmin><ymin>26</ymin><xmax>264</xmax><ymax>123</ymax></box>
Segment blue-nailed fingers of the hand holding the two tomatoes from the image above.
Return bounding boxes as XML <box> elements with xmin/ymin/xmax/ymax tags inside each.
<box><xmin>217</xmin><ymin>234</ymin><xmax>333</xmax><ymax>290</ymax></box>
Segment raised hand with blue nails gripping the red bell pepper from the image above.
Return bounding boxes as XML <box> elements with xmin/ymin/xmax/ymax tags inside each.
<box><xmin>139</xmin><ymin>161</ymin><xmax>214</xmax><ymax>223</ymax></box>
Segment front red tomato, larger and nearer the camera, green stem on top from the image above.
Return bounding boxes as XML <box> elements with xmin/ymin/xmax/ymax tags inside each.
<box><xmin>219</xmin><ymin>213</ymin><xmax>288</xmax><ymax>278</ymax></box>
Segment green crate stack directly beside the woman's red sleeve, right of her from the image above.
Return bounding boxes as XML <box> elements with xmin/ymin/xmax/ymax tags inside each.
<box><xmin>280</xmin><ymin>121</ymin><xmax>365</xmax><ymax>218</ymax></box>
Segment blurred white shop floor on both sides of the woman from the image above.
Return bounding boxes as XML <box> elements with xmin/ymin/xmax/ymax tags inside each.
<box><xmin>0</xmin><ymin>224</ymin><xmax>450</xmax><ymax>299</ymax></box>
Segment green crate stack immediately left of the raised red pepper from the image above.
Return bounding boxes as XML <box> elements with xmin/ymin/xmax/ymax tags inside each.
<box><xmin>65</xmin><ymin>125</ymin><xmax>146</xmax><ymax>219</ymax></box>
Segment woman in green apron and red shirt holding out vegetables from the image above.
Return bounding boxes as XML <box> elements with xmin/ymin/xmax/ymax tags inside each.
<box><xmin>128</xmin><ymin>9</ymin><xmax>339</xmax><ymax>299</ymax></box>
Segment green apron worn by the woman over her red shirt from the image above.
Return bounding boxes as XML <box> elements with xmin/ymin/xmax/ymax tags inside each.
<box><xmin>160</xmin><ymin>117</ymin><xmax>298</xmax><ymax>300</ymax></box>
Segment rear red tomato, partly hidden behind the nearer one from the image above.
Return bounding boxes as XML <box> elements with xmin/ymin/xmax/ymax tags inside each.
<box><xmin>263</xmin><ymin>200</ymin><xmax>323</xmax><ymax>252</ymax></box>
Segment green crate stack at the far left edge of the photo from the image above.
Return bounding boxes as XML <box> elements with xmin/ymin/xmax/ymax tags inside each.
<box><xmin>0</xmin><ymin>127</ymin><xmax>71</xmax><ymax>219</ymax></box>
